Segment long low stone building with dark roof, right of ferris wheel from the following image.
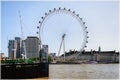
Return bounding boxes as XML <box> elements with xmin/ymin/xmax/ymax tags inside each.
<box><xmin>66</xmin><ymin>49</ymin><xmax>119</xmax><ymax>63</ymax></box>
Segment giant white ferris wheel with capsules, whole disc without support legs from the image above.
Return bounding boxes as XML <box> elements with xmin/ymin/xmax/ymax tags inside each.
<box><xmin>37</xmin><ymin>7</ymin><xmax>88</xmax><ymax>57</ymax></box>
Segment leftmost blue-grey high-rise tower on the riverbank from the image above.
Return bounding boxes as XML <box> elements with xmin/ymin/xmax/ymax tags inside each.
<box><xmin>8</xmin><ymin>40</ymin><xmax>17</xmax><ymax>59</ymax></box>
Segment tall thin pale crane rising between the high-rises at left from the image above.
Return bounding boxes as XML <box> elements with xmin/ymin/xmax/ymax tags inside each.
<box><xmin>19</xmin><ymin>11</ymin><xmax>27</xmax><ymax>59</ymax></box>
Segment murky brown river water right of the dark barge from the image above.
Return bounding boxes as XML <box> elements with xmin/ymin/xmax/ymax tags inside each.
<box><xmin>49</xmin><ymin>64</ymin><xmax>119</xmax><ymax>80</ymax></box>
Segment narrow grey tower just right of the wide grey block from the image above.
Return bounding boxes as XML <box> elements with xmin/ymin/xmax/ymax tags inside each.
<box><xmin>41</xmin><ymin>45</ymin><xmax>48</xmax><ymax>62</ymax></box>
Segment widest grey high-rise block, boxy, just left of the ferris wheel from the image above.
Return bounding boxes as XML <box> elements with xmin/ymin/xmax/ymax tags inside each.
<box><xmin>25</xmin><ymin>36</ymin><xmax>40</xmax><ymax>58</ymax></box>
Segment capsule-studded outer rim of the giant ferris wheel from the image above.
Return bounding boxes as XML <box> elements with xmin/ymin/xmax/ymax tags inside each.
<box><xmin>39</xmin><ymin>7</ymin><xmax>88</xmax><ymax>52</ymax></box>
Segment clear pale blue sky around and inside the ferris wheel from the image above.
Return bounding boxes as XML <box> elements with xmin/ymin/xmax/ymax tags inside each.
<box><xmin>0</xmin><ymin>1</ymin><xmax>119</xmax><ymax>56</ymax></box>
